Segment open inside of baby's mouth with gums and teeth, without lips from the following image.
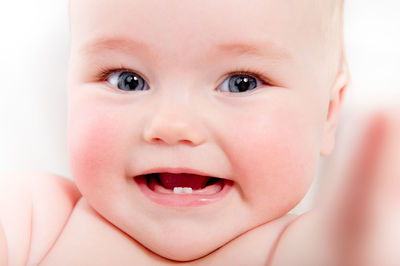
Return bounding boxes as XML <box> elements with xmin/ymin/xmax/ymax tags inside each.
<box><xmin>137</xmin><ymin>173</ymin><xmax>225</xmax><ymax>195</ymax></box>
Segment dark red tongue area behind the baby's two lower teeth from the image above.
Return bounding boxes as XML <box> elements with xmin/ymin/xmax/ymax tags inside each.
<box><xmin>158</xmin><ymin>173</ymin><xmax>210</xmax><ymax>189</ymax></box>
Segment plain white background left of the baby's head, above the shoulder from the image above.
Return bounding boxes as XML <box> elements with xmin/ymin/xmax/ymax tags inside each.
<box><xmin>0</xmin><ymin>0</ymin><xmax>69</xmax><ymax>175</ymax></box>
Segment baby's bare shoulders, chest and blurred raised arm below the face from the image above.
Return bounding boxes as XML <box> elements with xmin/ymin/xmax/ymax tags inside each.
<box><xmin>0</xmin><ymin>111</ymin><xmax>400</xmax><ymax>266</ymax></box>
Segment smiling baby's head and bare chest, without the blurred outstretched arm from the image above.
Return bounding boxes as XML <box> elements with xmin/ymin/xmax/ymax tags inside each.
<box><xmin>0</xmin><ymin>0</ymin><xmax>364</xmax><ymax>265</ymax></box>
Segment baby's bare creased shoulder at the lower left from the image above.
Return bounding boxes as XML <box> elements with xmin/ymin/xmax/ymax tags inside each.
<box><xmin>0</xmin><ymin>172</ymin><xmax>81</xmax><ymax>265</ymax></box>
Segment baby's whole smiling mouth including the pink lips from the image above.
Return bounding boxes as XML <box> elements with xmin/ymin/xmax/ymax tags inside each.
<box><xmin>134</xmin><ymin>172</ymin><xmax>234</xmax><ymax>206</ymax></box>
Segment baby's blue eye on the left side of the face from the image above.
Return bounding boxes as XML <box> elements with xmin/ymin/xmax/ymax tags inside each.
<box><xmin>107</xmin><ymin>71</ymin><xmax>149</xmax><ymax>91</ymax></box>
